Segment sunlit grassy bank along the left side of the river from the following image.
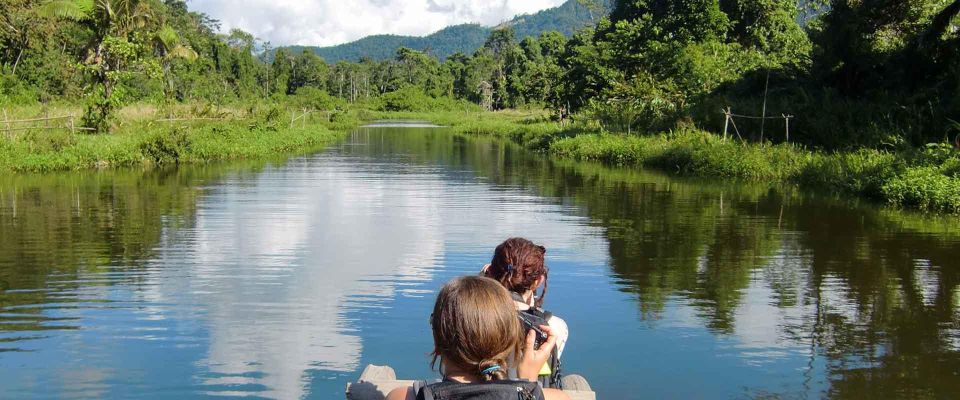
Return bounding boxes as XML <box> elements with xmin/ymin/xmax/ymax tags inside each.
<box><xmin>0</xmin><ymin>106</ymin><xmax>360</xmax><ymax>172</ymax></box>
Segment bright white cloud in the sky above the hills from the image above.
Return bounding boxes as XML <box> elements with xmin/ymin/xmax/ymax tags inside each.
<box><xmin>190</xmin><ymin>0</ymin><xmax>565</xmax><ymax>46</ymax></box>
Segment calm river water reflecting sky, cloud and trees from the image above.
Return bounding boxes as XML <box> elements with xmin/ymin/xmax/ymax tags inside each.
<box><xmin>0</xmin><ymin>127</ymin><xmax>960</xmax><ymax>399</ymax></box>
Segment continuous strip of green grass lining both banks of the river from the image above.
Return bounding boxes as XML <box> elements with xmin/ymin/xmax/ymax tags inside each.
<box><xmin>7</xmin><ymin>105</ymin><xmax>960</xmax><ymax>213</ymax></box>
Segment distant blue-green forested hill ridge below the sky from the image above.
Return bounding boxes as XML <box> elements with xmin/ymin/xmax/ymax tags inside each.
<box><xmin>271</xmin><ymin>0</ymin><xmax>611</xmax><ymax>63</ymax></box>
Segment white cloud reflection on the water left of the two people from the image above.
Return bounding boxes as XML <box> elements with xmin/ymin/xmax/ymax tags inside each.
<box><xmin>152</xmin><ymin>163</ymin><xmax>454</xmax><ymax>398</ymax></box>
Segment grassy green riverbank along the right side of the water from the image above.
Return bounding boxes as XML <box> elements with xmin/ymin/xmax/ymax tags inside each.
<box><xmin>378</xmin><ymin>112</ymin><xmax>960</xmax><ymax>213</ymax></box>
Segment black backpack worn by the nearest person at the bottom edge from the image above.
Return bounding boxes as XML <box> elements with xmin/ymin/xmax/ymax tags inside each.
<box><xmin>413</xmin><ymin>381</ymin><xmax>545</xmax><ymax>400</ymax></box>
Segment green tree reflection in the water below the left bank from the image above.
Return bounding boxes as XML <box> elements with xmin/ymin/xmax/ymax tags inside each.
<box><xmin>0</xmin><ymin>166</ymin><xmax>266</xmax><ymax>338</ymax></box>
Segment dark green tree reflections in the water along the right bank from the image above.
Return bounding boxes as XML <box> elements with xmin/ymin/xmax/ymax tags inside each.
<box><xmin>358</xmin><ymin>132</ymin><xmax>960</xmax><ymax>398</ymax></box>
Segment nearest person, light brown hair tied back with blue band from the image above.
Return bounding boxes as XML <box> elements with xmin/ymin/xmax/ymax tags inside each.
<box><xmin>387</xmin><ymin>276</ymin><xmax>569</xmax><ymax>400</ymax></box>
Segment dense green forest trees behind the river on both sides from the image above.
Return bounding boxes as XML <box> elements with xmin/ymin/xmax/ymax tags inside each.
<box><xmin>0</xmin><ymin>0</ymin><xmax>960</xmax><ymax>210</ymax></box>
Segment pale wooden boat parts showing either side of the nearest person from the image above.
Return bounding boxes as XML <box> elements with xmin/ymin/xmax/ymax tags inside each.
<box><xmin>347</xmin><ymin>365</ymin><xmax>597</xmax><ymax>400</ymax></box>
